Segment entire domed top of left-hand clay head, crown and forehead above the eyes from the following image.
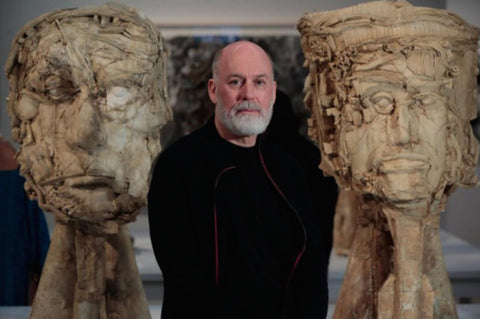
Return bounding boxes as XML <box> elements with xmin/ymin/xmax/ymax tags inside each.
<box><xmin>5</xmin><ymin>4</ymin><xmax>166</xmax><ymax>94</ymax></box>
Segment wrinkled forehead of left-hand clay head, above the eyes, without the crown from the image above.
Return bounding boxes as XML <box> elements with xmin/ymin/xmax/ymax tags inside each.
<box><xmin>18</xmin><ymin>17</ymin><xmax>159</xmax><ymax>83</ymax></box>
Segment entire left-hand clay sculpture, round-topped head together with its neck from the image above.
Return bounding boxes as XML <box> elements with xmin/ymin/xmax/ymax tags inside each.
<box><xmin>5</xmin><ymin>4</ymin><xmax>171</xmax><ymax>319</ymax></box>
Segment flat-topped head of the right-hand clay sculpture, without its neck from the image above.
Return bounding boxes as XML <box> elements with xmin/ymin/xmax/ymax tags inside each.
<box><xmin>297</xmin><ymin>1</ymin><xmax>479</xmax><ymax>209</ymax></box>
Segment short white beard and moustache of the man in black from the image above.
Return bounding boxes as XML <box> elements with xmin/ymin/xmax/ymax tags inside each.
<box><xmin>215</xmin><ymin>96</ymin><xmax>273</xmax><ymax>136</ymax></box>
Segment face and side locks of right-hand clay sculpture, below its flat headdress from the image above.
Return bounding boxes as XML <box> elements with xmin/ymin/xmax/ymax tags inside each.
<box><xmin>327</xmin><ymin>43</ymin><xmax>478</xmax><ymax>206</ymax></box>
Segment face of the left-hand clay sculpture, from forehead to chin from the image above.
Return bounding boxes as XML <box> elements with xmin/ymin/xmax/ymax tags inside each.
<box><xmin>9</xmin><ymin>24</ymin><xmax>165</xmax><ymax>221</ymax></box>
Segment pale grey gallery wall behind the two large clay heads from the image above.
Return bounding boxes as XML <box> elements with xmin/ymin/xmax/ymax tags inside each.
<box><xmin>0</xmin><ymin>0</ymin><xmax>480</xmax><ymax>247</ymax></box>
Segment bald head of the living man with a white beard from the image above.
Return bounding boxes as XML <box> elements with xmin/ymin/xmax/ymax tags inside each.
<box><xmin>209</xmin><ymin>43</ymin><xmax>276</xmax><ymax>136</ymax></box>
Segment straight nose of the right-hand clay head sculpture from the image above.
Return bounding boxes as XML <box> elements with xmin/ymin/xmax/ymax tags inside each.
<box><xmin>387</xmin><ymin>100</ymin><xmax>418</xmax><ymax>145</ymax></box>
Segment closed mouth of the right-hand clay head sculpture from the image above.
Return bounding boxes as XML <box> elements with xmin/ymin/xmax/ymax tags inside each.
<box><xmin>379</xmin><ymin>154</ymin><xmax>430</xmax><ymax>174</ymax></box>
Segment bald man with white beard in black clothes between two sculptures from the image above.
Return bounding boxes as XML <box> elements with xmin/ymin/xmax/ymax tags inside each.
<box><xmin>148</xmin><ymin>41</ymin><xmax>328</xmax><ymax>318</ymax></box>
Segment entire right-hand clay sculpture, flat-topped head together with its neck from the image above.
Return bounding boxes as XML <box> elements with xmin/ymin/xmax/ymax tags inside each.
<box><xmin>297</xmin><ymin>1</ymin><xmax>479</xmax><ymax>319</ymax></box>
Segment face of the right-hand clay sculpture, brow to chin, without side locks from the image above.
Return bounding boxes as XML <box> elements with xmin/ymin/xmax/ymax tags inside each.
<box><xmin>338</xmin><ymin>60</ymin><xmax>448</xmax><ymax>204</ymax></box>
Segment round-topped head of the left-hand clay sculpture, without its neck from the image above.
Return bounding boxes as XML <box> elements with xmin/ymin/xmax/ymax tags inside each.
<box><xmin>6</xmin><ymin>4</ymin><xmax>171</xmax><ymax>228</ymax></box>
